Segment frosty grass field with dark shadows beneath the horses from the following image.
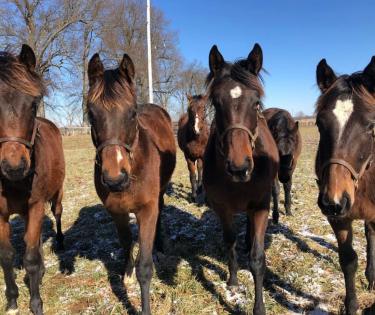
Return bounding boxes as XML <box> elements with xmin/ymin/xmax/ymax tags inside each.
<box><xmin>0</xmin><ymin>127</ymin><xmax>375</xmax><ymax>315</ymax></box>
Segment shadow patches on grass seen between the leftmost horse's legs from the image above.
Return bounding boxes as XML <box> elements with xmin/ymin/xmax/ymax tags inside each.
<box><xmin>9</xmin><ymin>215</ymin><xmax>56</xmax><ymax>269</ymax></box>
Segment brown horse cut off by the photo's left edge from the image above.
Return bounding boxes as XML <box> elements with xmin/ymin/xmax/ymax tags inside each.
<box><xmin>0</xmin><ymin>45</ymin><xmax>65</xmax><ymax>315</ymax></box>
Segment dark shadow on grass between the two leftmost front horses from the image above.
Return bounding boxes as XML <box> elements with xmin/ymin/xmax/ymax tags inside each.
<box><xmin>53</xmin><ymin>204</ymin><xmax>137</xmax><ymax>314</ymax></box>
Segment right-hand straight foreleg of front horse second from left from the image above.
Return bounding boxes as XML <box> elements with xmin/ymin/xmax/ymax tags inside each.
<box><xmin>136</xmin><ymin>203</ymin><xmax>158</xmax><ymax>315</ymax></box>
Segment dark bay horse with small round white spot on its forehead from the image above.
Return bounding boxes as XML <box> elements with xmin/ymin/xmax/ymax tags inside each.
<box><xmin>203</xmin><ymin>44</ymin><xmax>279</xmax><ymax>315</ymax></box>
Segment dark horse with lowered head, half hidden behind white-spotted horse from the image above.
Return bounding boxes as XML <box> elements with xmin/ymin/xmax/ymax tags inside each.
<box><xmin>263</xmin><ymin>108</ymin><xmax>302</xmax><ymax>224</ymax></box>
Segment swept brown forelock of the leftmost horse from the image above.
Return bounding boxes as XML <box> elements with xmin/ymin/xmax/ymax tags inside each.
<box><xmin>0</xmin><ymin>52</ymin><xmax>46</xmax><ymax>97</ymax></box>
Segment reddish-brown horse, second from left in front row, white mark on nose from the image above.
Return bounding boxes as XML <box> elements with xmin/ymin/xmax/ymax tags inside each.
<box><xmin>88</xmin><ymin>54</ymin><xmax>176</xmax><ymax>314</ymax></box>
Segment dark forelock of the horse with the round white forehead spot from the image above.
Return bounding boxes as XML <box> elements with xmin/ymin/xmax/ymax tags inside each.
<box><xmin>205</xmin><ymin>59</ymin><xmax>264</xmax><ymax>101</ymax></box>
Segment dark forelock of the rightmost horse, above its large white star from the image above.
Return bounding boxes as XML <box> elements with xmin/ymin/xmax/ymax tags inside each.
<box><xmin>316</xmin><ymin>71</ymin><xmax>375</xmax><ymax>112</ymax></box>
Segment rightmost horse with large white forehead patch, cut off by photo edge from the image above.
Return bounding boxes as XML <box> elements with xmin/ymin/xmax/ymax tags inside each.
<box><xmin>315</xmin><ymin>56</ymin><xmax>375</xmax><ymax>314</ymax></box>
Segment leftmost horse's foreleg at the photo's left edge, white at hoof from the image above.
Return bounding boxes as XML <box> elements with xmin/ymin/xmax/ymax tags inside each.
<box><xmin>0</xmin><ymin>216</ymin><xmax>18</xmax><ymax>314</ymax></box>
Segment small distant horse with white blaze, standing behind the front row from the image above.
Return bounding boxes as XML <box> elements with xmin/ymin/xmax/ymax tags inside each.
<box><xmin>177</xmin><ymin>95</ymin><xmax>209</xmax><ymax>202</ymax></box>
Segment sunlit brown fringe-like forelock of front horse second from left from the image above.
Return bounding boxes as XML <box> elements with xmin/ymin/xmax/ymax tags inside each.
<box><xmin>87</xmin><ymin>69</ymin><xmax>136</xmax><ymax>110</ymax></box>
